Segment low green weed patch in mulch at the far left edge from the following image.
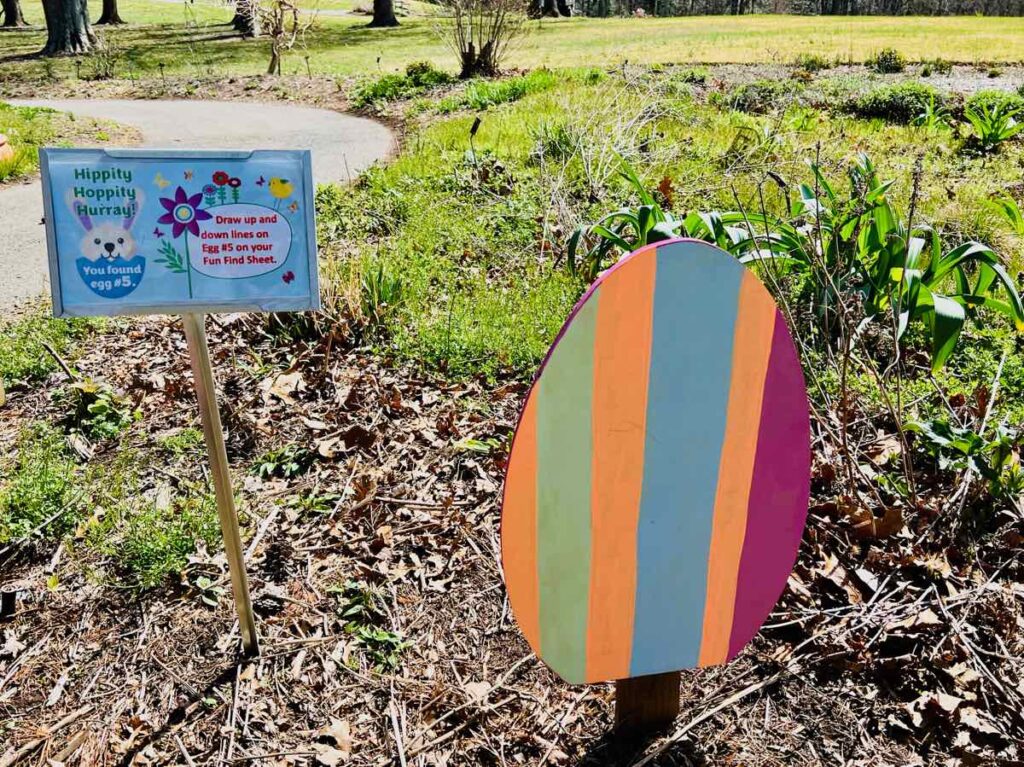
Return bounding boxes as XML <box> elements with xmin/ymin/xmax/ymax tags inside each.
<box><xmin>0</xmin><ymin>423</ymin><xmax>83</xmax><ymax>544</ymax></box>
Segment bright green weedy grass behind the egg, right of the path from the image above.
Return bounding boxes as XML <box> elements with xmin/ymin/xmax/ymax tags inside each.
<box><xmin>311</xmin><ymin>72</ymin><xmax>1024</xmax><ymax>378</ymax></box>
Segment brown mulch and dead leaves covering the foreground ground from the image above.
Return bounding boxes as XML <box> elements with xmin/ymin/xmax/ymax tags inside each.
<box><xmin>0</xmin><ymin>307</ymin><xmax>1024</xmax><ymax>767</ymax></box>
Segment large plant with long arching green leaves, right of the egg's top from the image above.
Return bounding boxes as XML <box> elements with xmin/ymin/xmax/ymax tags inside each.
<box><xmin>722</xmin><ymin>155</ymin><xmax>1024</xmax><ymax>370</ymax></box>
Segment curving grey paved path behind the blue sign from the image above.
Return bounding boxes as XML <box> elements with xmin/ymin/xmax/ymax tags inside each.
<box><xmin>0</xmin><ymin>99</ymin><xmax>395</xmax><ymax>314</ymax></box>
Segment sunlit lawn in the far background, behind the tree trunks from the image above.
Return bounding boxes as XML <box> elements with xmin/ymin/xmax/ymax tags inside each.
<box><xmin>0</xmin><ymin>0</ymin><xmax>1024</xmax><ymax>76</ymax></box>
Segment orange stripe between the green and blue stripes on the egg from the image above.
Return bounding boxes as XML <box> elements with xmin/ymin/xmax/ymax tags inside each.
<box><xmin>587</xmin><ymin>253</ymin><xmax>657</xmax><ymax>680</ymax></box>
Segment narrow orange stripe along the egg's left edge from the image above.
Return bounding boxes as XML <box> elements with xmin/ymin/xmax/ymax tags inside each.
<box><xmin>502</xmin><ymin>386</ymin><xmax>541</xmax><ymax>654</ymax></box>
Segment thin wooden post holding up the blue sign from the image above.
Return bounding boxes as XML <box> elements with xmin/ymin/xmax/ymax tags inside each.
<box><xmin>181</xmin><ymin>314</ymin><xmax>259</xmax><ymax>656</ymax></box>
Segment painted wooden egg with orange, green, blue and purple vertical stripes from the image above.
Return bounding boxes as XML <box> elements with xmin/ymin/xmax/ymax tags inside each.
<box><xmin>502</xmin><ymin>240</ymin><xmax>810</xmax><ymax>683</ymax></box>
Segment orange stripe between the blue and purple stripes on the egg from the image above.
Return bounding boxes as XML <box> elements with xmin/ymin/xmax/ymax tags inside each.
<box><xmin>700</xmin><ymin>271</ymin><xmax>776</xmax><ymax>666</ymax></box>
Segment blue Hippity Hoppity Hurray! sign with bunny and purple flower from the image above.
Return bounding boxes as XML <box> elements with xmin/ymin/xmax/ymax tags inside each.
<box><xmin>40</xmin><ymin>148</ymin><xmax>319</xmax><ymax>316</ymax></box>
